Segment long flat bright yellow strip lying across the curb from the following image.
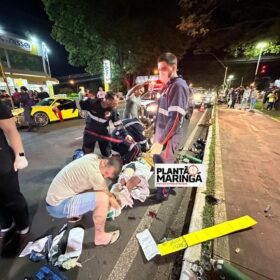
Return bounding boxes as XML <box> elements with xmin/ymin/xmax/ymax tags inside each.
<box><xmin>158</xmin><ymin>216</ymin><xmax>257</xmax><ymax>256</ymax></box>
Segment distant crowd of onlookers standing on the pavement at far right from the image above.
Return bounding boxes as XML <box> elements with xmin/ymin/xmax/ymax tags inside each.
<box><xmin>226</xmin><ymin>85</ymin><xmax>280</xmax><ymax>112</ymax></box>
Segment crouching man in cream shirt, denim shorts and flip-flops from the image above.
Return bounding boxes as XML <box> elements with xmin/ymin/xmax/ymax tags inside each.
<box><xmin>46</xmin><ymin>154</ymin><xmax>121</xmax><ymax>245</ymax></box>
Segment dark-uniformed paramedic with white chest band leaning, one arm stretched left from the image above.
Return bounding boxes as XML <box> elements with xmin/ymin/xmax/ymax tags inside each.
<box><xmin>53</xmin><ymin>92</ymin><xmax>132</xmax><ymax>157</ymax></box>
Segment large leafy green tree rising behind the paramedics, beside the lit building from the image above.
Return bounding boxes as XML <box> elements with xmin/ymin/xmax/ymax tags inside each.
<box><xmin>43</xmin><ymin>0</ymin><xmax>185</xmax><ymax>89</ymax></box>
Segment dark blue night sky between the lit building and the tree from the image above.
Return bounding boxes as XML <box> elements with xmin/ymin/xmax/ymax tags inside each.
<box><xmin>0</xmin><ymin>0</ymin><xmax>84</xmax><ymax>77</ymax></box>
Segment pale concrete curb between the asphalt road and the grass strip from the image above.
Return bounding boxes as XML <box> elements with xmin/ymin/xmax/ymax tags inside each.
<box><xmin>180</xmin><ymin>108</ymin><xmax>215</xmax><ymax>280</ymax></box>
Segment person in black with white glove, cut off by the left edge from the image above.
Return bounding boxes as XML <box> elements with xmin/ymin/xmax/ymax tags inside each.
<box><xmin>0</xmin><ymin>101</ymin><xmax>29</xmax><ymax>234</ymax></box>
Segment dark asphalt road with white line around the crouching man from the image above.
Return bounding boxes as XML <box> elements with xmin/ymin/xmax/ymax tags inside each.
<box><xmin>0</xmin><ymin>105</ymin><xmax>206</xmax><ymax>280</ymax></box>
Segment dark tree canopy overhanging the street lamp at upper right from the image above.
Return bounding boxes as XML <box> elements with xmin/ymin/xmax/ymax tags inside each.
<box><xmin>177</xmin><ymin>0</ymin><xmax>280</xmax><ymax>56</ymax></box>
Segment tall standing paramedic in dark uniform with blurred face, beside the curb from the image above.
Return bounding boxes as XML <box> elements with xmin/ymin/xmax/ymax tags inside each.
<box><xmin>150</xmin><ymin>53</ymin><xmax>189</xmax><ymax>202</ymax></box>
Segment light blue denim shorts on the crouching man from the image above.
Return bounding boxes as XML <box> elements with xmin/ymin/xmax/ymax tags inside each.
<box><xmin>46</xmin><ymin>192</ymin><xmax>96</xmax><ymax>218</ymax></box>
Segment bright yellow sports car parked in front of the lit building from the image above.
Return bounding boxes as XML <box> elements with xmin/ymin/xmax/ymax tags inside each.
<box><xmin>13</xmin><ymin>97</ymin><xmax>85</xmax><ymax>126</ymax></box>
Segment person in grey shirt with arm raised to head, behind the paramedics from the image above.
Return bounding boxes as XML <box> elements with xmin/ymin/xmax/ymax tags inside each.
<box><xmin>123</xmin><ymin>84</ymin><xmax>145</xmax><ymax>119</ymax></box>
